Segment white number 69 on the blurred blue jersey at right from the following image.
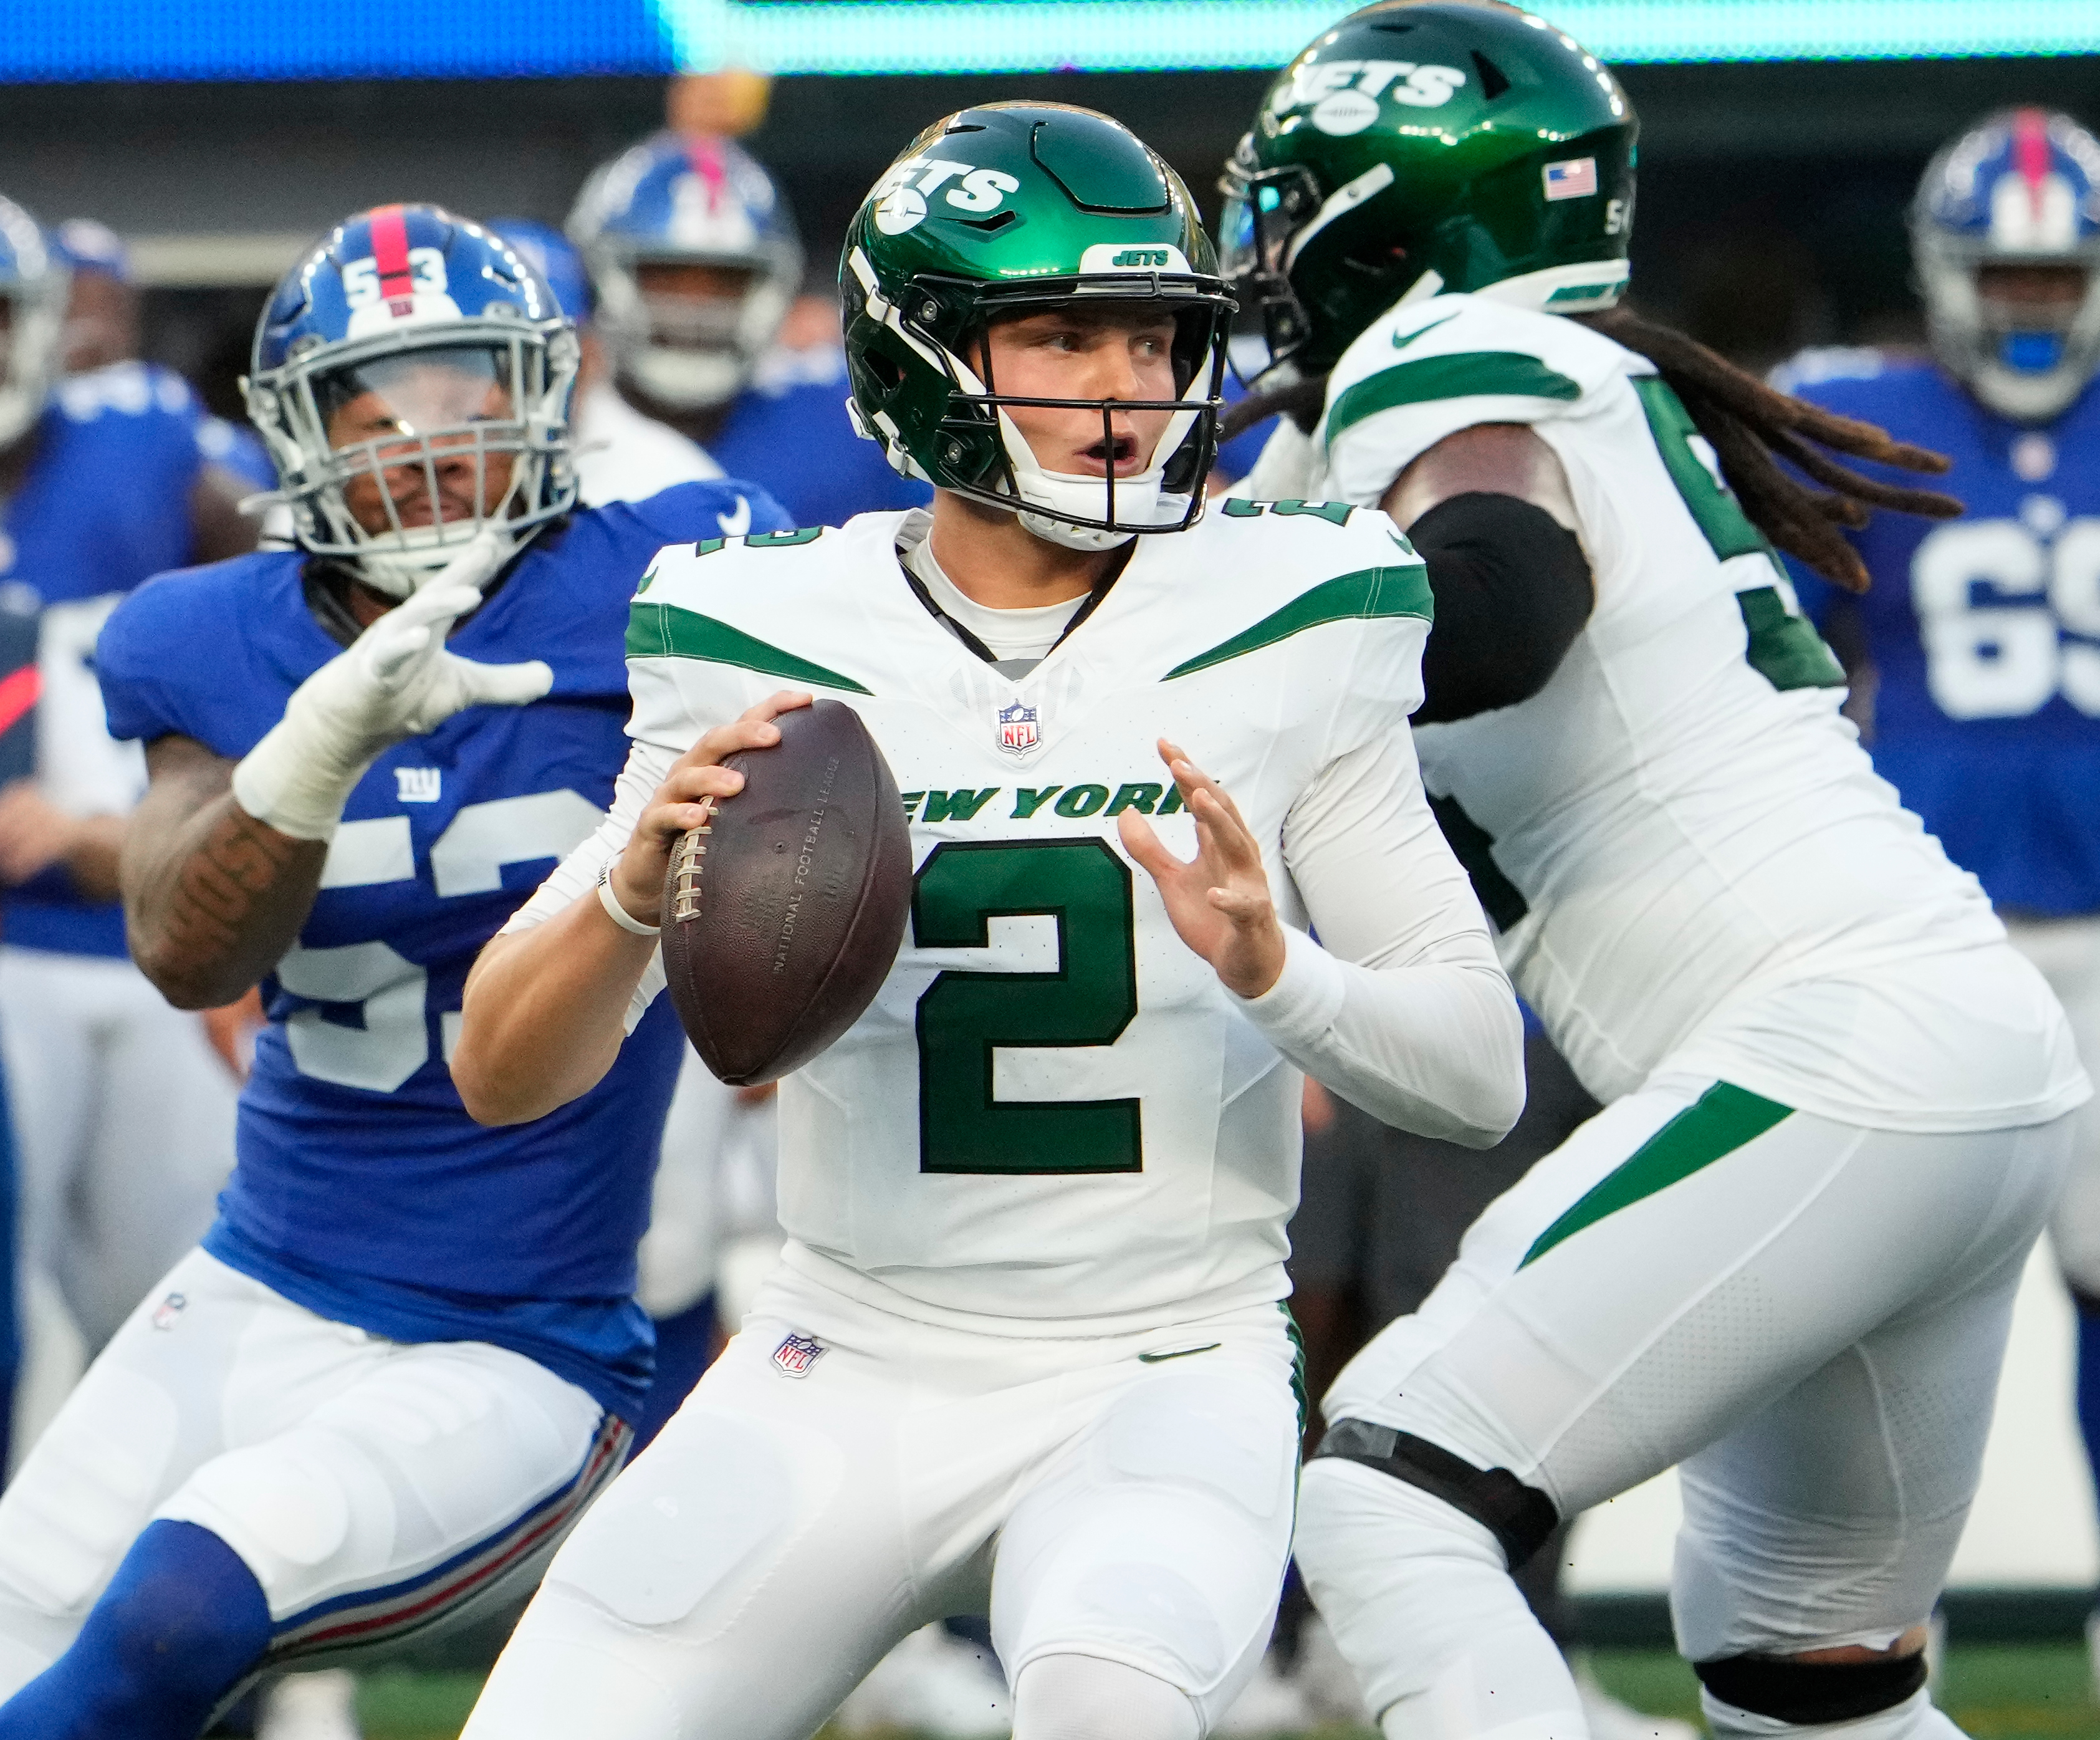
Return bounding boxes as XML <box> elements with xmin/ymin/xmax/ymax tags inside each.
<box><xmin>1911</xmin><ymin>519</ymin><xmax>2100</xmax><ymax>719</ymax></box>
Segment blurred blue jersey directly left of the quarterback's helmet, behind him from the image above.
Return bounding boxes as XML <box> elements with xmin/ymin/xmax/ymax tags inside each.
<box><xmin>707</xmin><ymin>345</ymin><xmax>933</xmax><ymax>526</ymax></box>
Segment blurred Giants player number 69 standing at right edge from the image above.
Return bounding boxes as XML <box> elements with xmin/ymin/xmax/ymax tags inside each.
<box><xmin>1775</xmin><ymin>109</ymin><xmax>2100</xmax><ymax>1673</ymax></box>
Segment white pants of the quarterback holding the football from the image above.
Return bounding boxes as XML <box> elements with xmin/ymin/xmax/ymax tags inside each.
<box><xmin>466</xmin><ymin>1269</ymin><xmax>1298</xmax><ymax>1740</ymax></box>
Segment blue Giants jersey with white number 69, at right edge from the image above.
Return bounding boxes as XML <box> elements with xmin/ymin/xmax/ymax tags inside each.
<box><xmin>1779</xmin><ymin>351</ymin><xmax>2100</xmax><ymax>914</ymax></box>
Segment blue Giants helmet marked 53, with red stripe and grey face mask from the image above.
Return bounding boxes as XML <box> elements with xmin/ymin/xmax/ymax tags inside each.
<box><xmin>246</xmin><ymin>206</ymin><xmax>577</xmax><ymax>597</ymax></box>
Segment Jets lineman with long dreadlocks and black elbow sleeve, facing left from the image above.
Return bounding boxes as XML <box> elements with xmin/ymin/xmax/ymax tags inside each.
<box><xmin>1222</xmin><ymin>0</ymin><xmax>2092</xmax><ymax>1740</ymax></box>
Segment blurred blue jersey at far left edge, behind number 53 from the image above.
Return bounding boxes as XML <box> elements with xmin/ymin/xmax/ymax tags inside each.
<box><xmin>0</xmin><ymin>363</ymin><xmax>224</xmax><ymax>954</ymax></box>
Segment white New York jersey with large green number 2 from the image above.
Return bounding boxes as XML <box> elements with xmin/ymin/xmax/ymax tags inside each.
<box><xmin>521</xmin><ymin>502</ymin><xmax>1516</xmax><ymax>1332</ymax></box>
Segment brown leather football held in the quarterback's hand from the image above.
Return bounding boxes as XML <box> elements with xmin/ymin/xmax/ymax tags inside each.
<box><xmin>664</xmin><ymin>699</ymin><xmax>911</xmax><ymax>1087</ymax></box>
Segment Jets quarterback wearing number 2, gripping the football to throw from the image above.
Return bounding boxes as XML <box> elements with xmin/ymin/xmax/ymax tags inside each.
<box><xmin>454</xmin><ymin>103</ymin><xmax>1523</xmax><ymax>1740</ymax></box>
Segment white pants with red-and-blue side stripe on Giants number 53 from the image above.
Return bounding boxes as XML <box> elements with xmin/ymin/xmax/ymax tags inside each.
<box><xmin>0</xmin><ymin>1251</ymin><xmax>628</xmax><ymax>1702</ymax></box>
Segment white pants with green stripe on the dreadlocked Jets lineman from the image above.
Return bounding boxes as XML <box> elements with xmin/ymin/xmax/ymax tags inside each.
<box><xmin>1296</xmin><ymin>1087</ymin><xmax>2073</xmax><ymax>1740</ymax></box>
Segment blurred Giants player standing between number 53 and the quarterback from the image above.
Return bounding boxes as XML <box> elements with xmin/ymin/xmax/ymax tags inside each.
<box><xmin>569</xmin><ymin>132</ymin><xmax>926</xmax><ymax>526</ymax></box>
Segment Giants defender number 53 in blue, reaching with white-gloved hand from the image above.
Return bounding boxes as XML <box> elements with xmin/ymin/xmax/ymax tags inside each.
<box><xmin>0</xmin><ymin>206</ymin><xmax>781</xmax><ymax>1740</ymax></box>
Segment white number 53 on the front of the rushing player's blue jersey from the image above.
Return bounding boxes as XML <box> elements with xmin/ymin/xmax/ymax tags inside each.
<box><xmin>277</xmin><ymin>790</ymin><xmax>598</xmax><ymax>1093</ymax></box>
